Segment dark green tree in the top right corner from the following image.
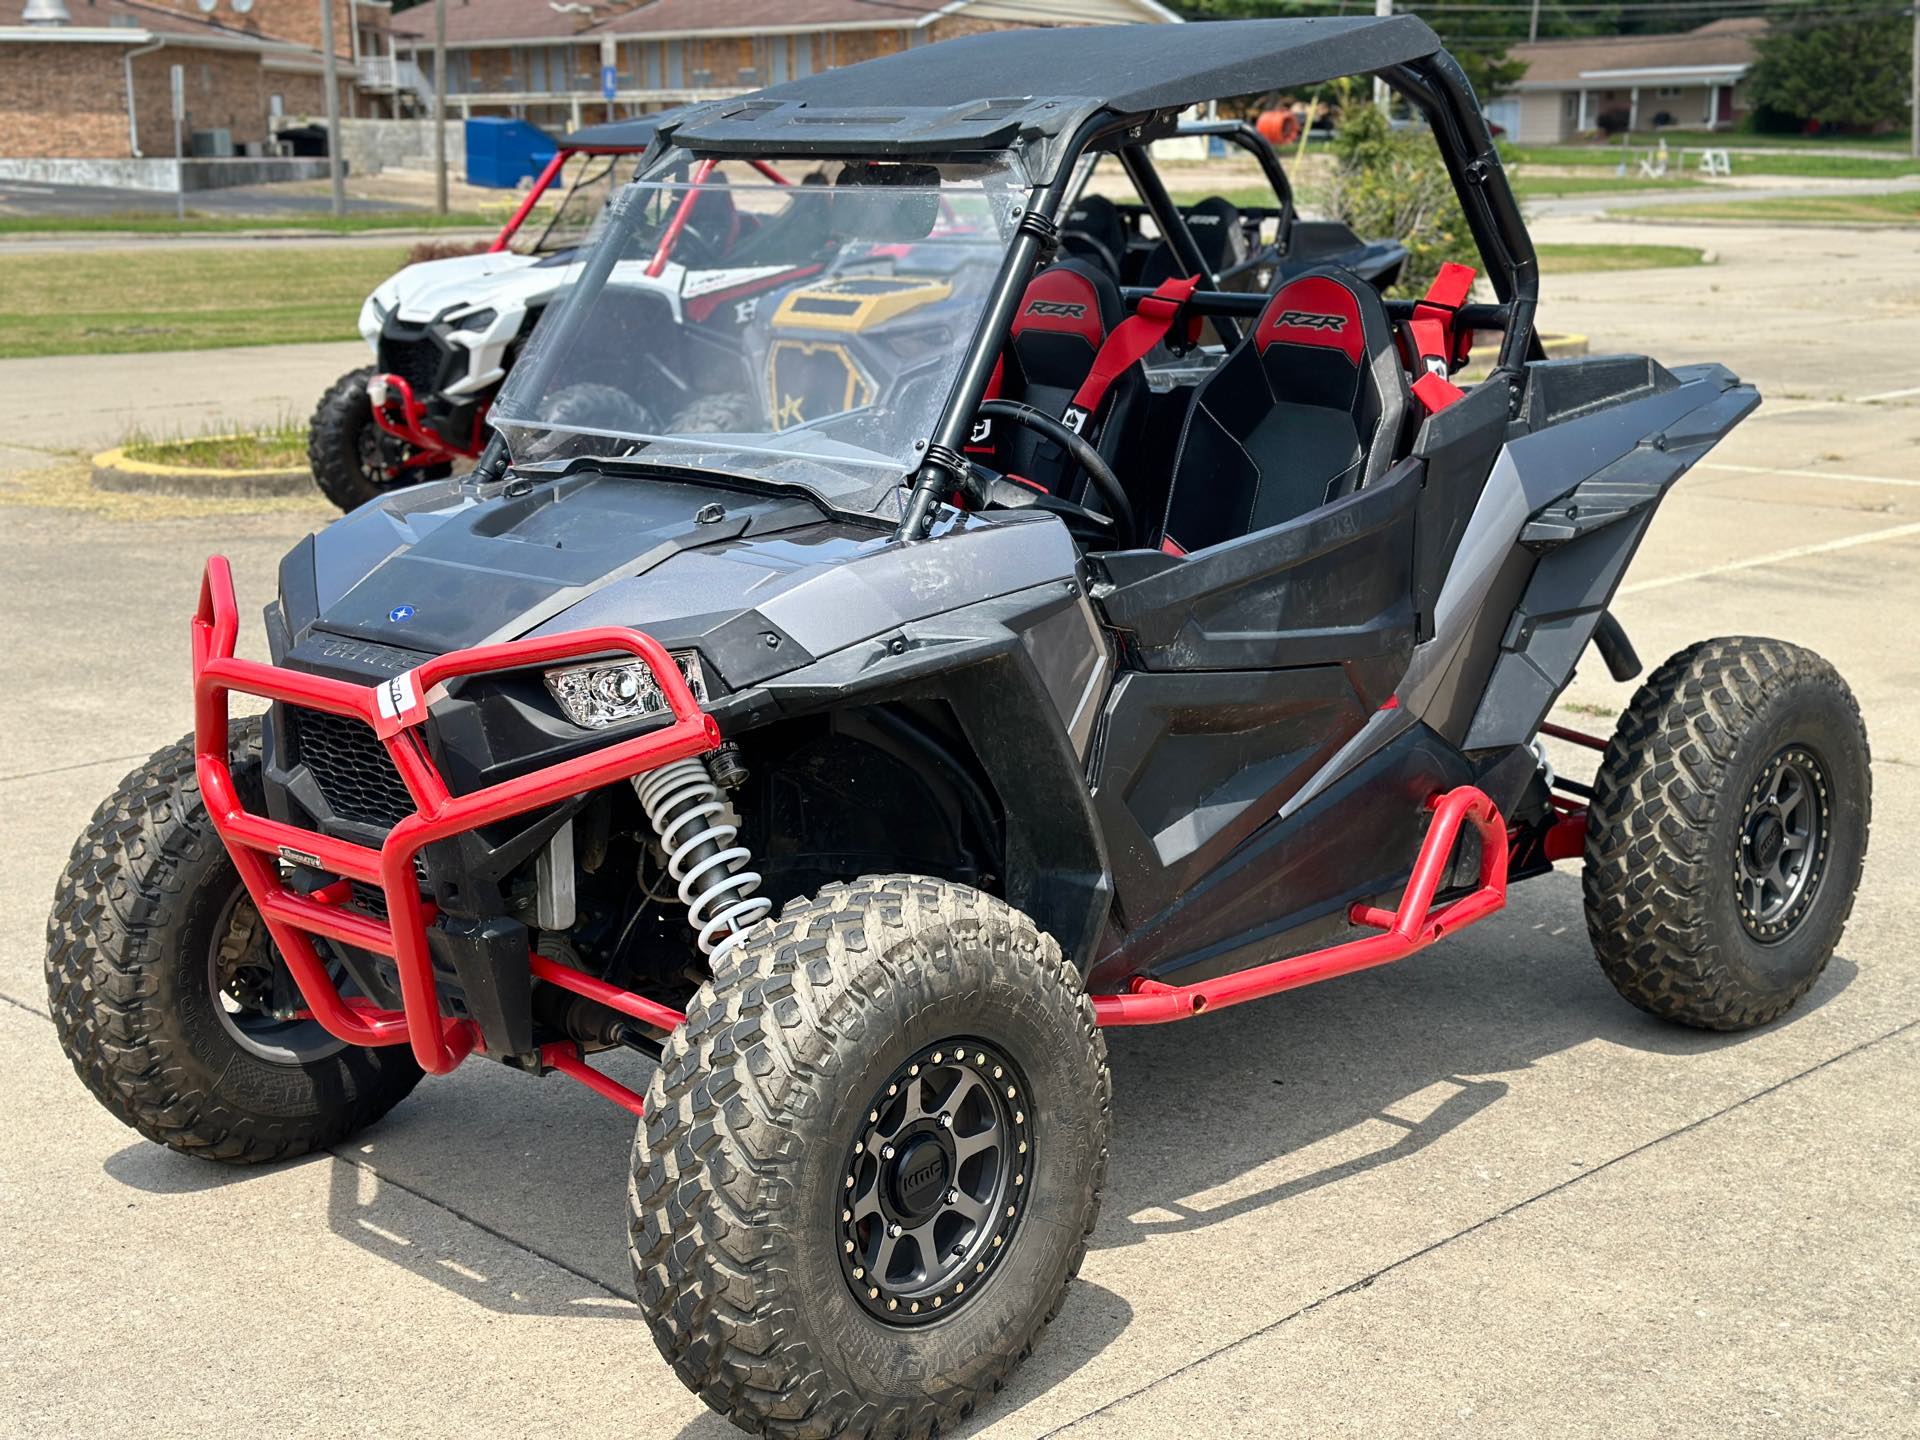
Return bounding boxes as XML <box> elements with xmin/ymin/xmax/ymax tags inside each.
<box><xmin>1751</xmin><ymin>4</ymin><xmax>1912</xmax><ymax>131</ymax></box>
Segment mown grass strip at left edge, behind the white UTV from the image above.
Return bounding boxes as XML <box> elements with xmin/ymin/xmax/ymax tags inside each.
<box><xmin>0</xmin><ymin>246</ymin><xmax>407</xmax><ymax>359</ymax></box>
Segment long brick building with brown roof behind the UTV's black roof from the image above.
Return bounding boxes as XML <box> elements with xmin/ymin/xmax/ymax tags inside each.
<box><xmin>392</xmin><ymin>0</ymin><xmax>1179</xmax><ymax>129</ymax></box>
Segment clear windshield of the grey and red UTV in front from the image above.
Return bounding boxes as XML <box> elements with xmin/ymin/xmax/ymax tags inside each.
<box><xmin>490</xmin><ymin>152</ymin><xmax>1023</xmax><ymax>515</ymax></box>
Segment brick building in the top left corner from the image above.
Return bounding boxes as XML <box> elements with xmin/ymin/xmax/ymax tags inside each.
<box><xmin>0</xmin><ymin>0</ymin><xmax>394</xmax><ymax>173</ymax></box>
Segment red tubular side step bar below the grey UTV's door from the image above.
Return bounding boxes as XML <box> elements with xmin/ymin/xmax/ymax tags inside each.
<box><xmin>1092</xmin><ymin>785</ymin><xmax>1507</xmax><ymax>1025</ymax></box>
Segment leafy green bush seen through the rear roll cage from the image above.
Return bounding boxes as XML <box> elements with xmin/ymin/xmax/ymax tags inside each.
<box><xmin>1327</xmin><ymin>104</ymin><xmax>1480</xmax><ymax>296</ymax></box>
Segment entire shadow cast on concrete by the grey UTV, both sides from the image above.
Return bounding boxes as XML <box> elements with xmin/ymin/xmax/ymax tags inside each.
<box><xmin>93</xmin><ymin>876</ymin><xmax>1855</xmax><ymax>1336</ymax></box>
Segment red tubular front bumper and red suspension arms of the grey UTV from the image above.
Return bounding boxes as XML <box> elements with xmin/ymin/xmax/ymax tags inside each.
<box><xmin>194</xmin><ymin>555</ymin><xmax>720</xmax><ymax>1112</ymax></box>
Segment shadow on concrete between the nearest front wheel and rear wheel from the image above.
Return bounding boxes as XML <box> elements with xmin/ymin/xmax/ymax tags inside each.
<box><xmin>1094</xmin><ymin>874</ymin><xmax>1855</xmax><ymax>1248</ymax></box>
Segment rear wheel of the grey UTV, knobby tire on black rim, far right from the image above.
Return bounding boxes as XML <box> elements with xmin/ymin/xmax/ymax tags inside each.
<box><xmin>1584</xmin><ymin>637</ymin><xmax>1872</xmax><ymax>1029</ymax></box>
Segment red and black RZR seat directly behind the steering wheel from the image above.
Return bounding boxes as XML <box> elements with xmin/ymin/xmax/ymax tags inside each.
<box><xmin>968</xmin><ymin>259</ymin><xmax>1146</xmax><ymax>509</ymax></box>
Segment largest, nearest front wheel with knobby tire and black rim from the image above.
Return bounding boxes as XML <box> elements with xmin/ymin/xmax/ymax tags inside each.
<box><xmin>630</xmin><ymin>876</ymin><xmax>1112</xmax><ymax>1436</ymax></box>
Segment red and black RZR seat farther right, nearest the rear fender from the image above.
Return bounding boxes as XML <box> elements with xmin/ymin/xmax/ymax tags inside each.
<box><xmin>1162</xmin><ymin>265</ymin><xmax>1409</xmax><ymax>555</ymax></box>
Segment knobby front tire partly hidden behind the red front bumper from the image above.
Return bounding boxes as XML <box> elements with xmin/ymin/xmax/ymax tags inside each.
<box><xmin>46</xmin><ymin>718</ymin><xmax>420</xmax><ymax>1164</ymax></box>
